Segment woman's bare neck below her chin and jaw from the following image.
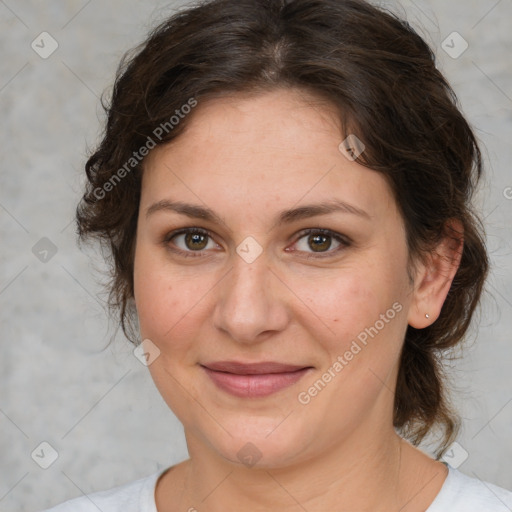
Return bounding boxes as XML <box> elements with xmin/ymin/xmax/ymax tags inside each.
<box><xmin>166</xmin><ymin>429</ymin><xmax>438</xmax><ymax>512</ymax></box>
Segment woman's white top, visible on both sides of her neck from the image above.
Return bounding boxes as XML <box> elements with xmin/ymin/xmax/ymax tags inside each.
<box><xmin>41</xmin><ymin>465</ymin><xmax>512</xmax><ymax>512</ymax></box>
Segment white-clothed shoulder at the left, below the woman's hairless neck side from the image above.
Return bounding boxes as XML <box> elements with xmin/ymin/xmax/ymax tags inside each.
<box><xmin>42</xmin><ymin>471</ymin><xmax>162</xmax><ymax>512</ymax></box>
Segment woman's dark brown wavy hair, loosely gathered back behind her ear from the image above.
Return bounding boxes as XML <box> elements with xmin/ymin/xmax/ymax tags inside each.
<box><xmin>77</xmin><ymin>0</ymin><xmax>489</xmax><ymax>458</ymax></box>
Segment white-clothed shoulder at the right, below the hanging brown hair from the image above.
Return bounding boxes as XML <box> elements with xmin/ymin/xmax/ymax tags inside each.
<box><xmin>426</xmin><ymin>466</ymin><xmax>512</xmax><ymax>512</ymax></box>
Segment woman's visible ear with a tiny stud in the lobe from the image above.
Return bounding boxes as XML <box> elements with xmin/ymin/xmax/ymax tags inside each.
<box><xmin>408</xmin><ymin>219</ymin><xmax>464</xmax><ymax>329</ymax></box>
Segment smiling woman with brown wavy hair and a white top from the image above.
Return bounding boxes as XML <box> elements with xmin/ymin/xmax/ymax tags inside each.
<box><xmin>41</xmin><ymin>0</ymin><xmax>512</xmax><ymax>512</ymax></box>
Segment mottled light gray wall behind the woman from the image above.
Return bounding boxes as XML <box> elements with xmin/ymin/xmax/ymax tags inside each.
<box><xmin>0</xmin><ymin>0</ymin><xmax>512</xmax><ymax>512</ymax></box>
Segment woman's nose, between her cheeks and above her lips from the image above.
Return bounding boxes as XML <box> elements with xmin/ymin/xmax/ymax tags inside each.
<box><xmin>213</xmin><ymin>254</ymin><xmax>290</xmax><ymax>344</ymax></box>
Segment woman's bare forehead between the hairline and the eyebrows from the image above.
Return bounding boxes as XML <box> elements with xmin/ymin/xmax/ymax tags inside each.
<box><xmin>142</xmin><ymin>89</ymin><xmax>394</xmax><ymax>222</ymax></box>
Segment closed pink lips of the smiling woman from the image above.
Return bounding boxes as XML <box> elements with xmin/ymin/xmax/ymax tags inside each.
<box><xmin>201</xmin><ymin>361</ymin><xmax>311</xmax><ymax>398</ymax></box>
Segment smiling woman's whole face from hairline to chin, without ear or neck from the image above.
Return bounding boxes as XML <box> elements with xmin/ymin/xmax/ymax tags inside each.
<box><xmin>134</xmin><ymin>89</ymin><xmax>413</xmax><ymax>467</ymax></box>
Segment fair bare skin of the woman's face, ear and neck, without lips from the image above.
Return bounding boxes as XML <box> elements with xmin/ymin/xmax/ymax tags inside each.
<box><xmin>134</xmin><ymin>89</ymin><xmax>460</xmax><ymax>512</ymax></box>
